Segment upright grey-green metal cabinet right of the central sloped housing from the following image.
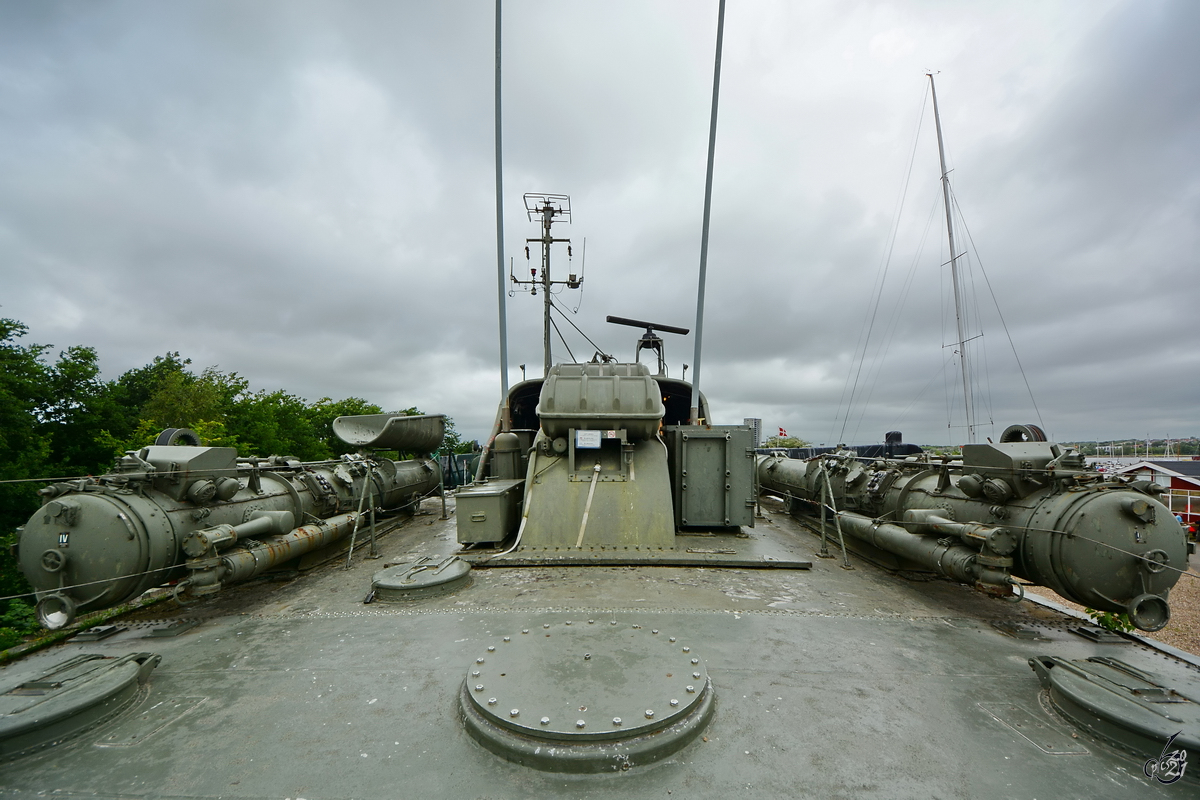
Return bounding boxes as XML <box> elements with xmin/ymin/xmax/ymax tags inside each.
<box><xmin>664</xmin><ymin>425</ymin><xmax>757</xmax><ymax>528</ymax></box>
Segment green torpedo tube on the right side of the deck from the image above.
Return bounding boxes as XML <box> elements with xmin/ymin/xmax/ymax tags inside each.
<box><xmin>758</xmin><ymin>441</ymin><xmax>1188</xmax><ymax>631</ymax></box>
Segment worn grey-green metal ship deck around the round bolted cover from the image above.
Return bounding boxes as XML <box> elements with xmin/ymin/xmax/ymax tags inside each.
<box><xmin>0</xmin><ymin>501</ymin><xmax>1200</xmax><ymax>799</ymax></box>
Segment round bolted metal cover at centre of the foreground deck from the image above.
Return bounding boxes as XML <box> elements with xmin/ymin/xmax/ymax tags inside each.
<box><xmin>460</xmin><ymin>619</ymin><xmax>714</xmax><ymax>772</ymax></box>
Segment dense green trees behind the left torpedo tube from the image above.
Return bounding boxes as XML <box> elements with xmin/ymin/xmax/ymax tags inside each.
<box><xmin>0</xmin><ymin>319</ymin><xmax>463</xmax><ymax>648</ymax></box>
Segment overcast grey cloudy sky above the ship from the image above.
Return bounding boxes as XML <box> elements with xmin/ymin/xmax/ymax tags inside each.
<box><xmin>0</xmin><ymin>0</ymin><xmax>1200</xmax><ymax>444</ymax></box>
